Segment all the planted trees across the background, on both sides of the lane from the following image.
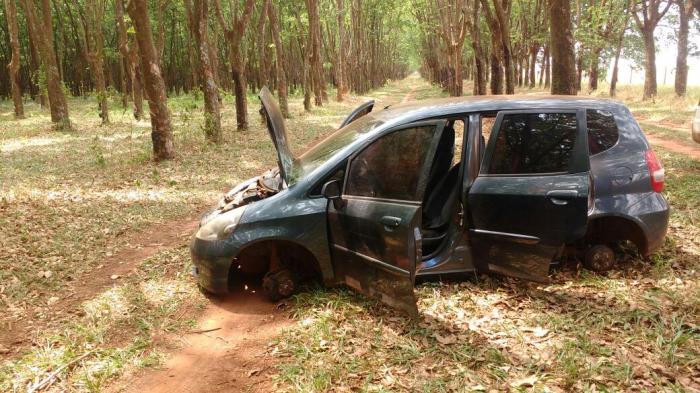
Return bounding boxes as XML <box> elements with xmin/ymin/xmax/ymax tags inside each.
<box><xmin>0</xmin><ymin>0</ymin><xmax>700</xmax><ymax>159</ymax></box>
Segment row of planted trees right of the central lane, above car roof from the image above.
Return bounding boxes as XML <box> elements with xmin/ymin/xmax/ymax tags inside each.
<box><xmin>415</xmin><ymin>0</ymin><xmax>700</xmax><ymax>99</ymax></box>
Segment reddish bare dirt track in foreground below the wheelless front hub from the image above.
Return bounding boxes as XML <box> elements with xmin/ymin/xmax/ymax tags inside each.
<box><xmin>113</xmin><ymin>85</ymin><xmax>426</xmax><ymax>393</ymax></box>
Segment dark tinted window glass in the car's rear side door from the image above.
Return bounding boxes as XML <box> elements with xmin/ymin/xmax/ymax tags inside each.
<box><xmin>487</xmin><ymin>113</ymin><xmax>576</xmax><ymax>174</ymax></box>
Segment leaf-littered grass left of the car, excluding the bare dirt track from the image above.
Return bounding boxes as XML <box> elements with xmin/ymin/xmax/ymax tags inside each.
<box><xmin>0</xmin><ymin>76</ymin><xmax>430</xmax><ymax>391</ymax></box>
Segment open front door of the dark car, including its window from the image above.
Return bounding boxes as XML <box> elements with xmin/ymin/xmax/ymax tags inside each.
<box><xmin>328</xmin><ymin>121</ymin><xmax>445</xmax><ymax>315</ymax></box>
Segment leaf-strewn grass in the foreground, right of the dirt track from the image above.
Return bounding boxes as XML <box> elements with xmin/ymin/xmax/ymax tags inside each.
<box><xmin>275</xmin><ymin>82</ymin><xmax>700</xmax><ymax>392</ymax></box>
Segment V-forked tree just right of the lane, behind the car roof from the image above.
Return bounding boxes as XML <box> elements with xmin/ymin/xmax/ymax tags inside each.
<box><xmin>433</xmin><ymin>0</ymin><xmax>470</xmax><ymax>97</ymax></box>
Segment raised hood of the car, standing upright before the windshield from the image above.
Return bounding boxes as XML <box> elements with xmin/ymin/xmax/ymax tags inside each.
<box><xmin>258</xmin><ymin>86</ymin><xmax>296</xmax><ymax>184</ymax></box>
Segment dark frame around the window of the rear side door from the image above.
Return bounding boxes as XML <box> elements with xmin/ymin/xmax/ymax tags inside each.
<box><xmin>479</xmin><ymin>107</ymin><xmax>590</xmax><ymax>177</ymax></box>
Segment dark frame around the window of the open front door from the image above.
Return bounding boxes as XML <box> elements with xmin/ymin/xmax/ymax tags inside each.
<box><xmin>341</xmin><ymin>119</ymin><xmax>447</xmax><ymax>206</ymax></box>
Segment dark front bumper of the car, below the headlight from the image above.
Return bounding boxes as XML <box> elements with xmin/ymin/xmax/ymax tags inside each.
<box><xmin>190</xmin><ymin>236</ymin><xmax>236</xmax><ymax>295</ymax></box>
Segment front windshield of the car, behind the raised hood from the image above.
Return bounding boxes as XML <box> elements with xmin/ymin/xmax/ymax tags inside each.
<box><xmin>289</xmin><ymin>114</ymin><xmax>384</xmax><ymax>186</ymax></box>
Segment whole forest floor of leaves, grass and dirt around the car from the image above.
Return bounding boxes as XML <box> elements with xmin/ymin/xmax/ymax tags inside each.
<box><xmin>0</xmin><ymin>77</ymin><xmax>700</xmax><ymax>391</ymax></box>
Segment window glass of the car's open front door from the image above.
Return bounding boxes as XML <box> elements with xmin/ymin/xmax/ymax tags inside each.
<box><xmin>345</xmin><ymin>126</ymin><xmax>435</xmax><ymax>201</ymax></box>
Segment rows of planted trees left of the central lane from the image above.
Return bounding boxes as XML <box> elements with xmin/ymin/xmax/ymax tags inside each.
<box><xmin>0</xmin><ymin>0</ymin><xmax>410</xmax><ymax>159</ymax></box>
